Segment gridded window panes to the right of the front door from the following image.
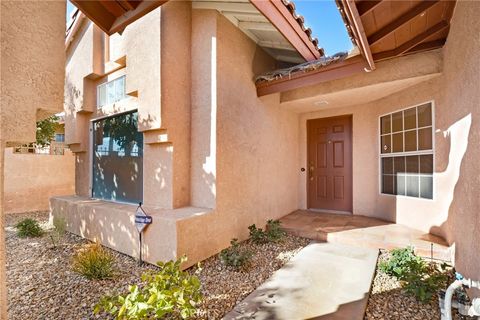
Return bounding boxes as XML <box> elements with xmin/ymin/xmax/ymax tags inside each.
<box><xmin>380</xmin><ymin>102</ymin><xmax>434</xmax><ymax>199</ymax></box>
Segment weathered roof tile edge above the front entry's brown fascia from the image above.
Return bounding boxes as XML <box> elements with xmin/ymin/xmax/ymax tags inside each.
<box><xmin>255</xmin><ymin>52</ymin><xmax>348</xmax><ymax>85</ymax></box>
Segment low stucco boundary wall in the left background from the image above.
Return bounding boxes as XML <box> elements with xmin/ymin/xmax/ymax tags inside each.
<box><xmin>4</xmin><ymin>148</ymin><xmax>75</xmax><ymax>213</ymax></box>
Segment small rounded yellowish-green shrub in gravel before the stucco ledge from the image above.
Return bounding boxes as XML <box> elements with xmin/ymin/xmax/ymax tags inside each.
<box><xmin>72</xmin><ymin>243</ymin><xmax>115</xmax><ymax>280</ymax></box>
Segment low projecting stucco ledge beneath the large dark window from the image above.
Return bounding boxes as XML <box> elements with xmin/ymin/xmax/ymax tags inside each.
<box><xmin>50</xmin><ymin>196</ymin><xmax>214</xmax><ymax>268</ymax></box>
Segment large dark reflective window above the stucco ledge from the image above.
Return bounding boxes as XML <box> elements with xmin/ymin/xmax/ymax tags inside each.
<box><xmin>92</xmin><ymin>111</ymin><xmax>143</xmax><ymax>203</ymax></box>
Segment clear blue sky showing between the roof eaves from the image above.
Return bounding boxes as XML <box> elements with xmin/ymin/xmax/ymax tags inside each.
<box><xmin>67</xmin><ymin>0</ymin><xmax>353</xmax><ymax>56</ymax></box>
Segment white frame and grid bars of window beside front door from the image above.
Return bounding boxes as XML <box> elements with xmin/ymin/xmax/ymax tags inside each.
<box><xmin>377</xmin><ymin>100</ymin><xmax>436</xmax><ymax>201</ymax></box>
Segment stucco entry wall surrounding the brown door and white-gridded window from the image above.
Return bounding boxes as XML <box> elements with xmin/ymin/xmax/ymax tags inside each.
<box><xmin>292</xmin><ymin>1</ymin><xmax>480</xmax><ymax>284</ymax></box>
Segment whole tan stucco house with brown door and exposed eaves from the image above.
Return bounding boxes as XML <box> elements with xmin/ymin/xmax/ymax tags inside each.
<box><xmin>51</xmin><ymin>0</ymin><xmax>480</xmax><ymax>288</ymax></box>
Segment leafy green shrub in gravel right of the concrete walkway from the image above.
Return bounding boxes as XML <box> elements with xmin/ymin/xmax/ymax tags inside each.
<box><xmin>379</xmin><ymin>247</ymin><xmax>448</xmax><ymax>303</ymax></box>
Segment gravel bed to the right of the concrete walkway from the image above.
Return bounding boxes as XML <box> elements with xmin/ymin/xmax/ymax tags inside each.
<box><xmin>365</xmin><ymin>251</ymin><xmax>462</xmax><ymax>320</ymax></box>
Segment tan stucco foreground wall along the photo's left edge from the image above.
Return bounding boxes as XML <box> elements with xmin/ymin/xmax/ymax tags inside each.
<box><xmin>0</xmin><ymin>1</ymin><xmax>66</xmax><ymax>319</ymax></box>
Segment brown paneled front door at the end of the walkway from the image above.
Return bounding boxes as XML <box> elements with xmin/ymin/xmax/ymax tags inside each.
<box><xmin>307</xmin><ymin>116</ymin><xmax>352</xmax><ymax>212</ymax></box>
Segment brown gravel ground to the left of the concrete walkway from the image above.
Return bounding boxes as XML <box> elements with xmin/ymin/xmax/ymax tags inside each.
<box><xmin>6</xmin><ymin>212</ymin><xmax>309</xmax><ymax>320</ymax></box>
